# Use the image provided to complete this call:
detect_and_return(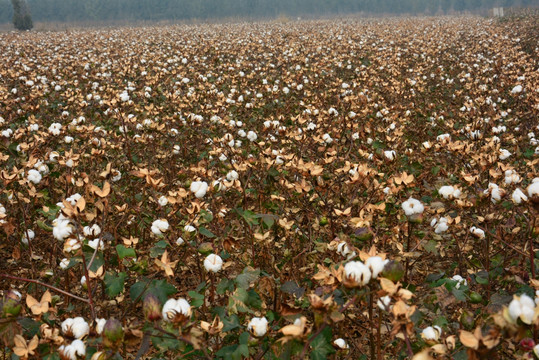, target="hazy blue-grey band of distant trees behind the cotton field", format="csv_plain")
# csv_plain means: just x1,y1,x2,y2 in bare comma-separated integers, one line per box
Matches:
0,0,539,23
